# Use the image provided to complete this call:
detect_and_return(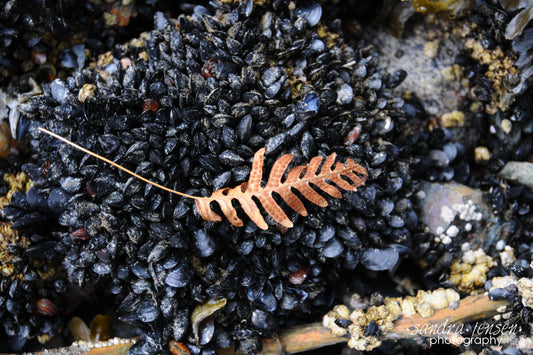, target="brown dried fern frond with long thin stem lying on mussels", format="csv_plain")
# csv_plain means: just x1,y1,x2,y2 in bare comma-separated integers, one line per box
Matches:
39,127,368,229
